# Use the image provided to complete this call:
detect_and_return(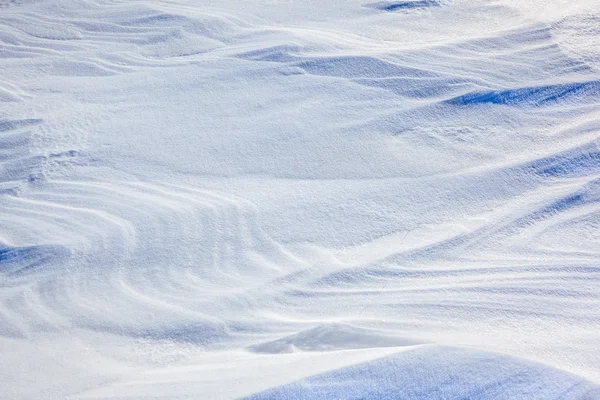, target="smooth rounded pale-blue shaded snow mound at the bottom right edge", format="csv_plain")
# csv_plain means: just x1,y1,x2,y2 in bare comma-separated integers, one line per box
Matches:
248,347,600,400
